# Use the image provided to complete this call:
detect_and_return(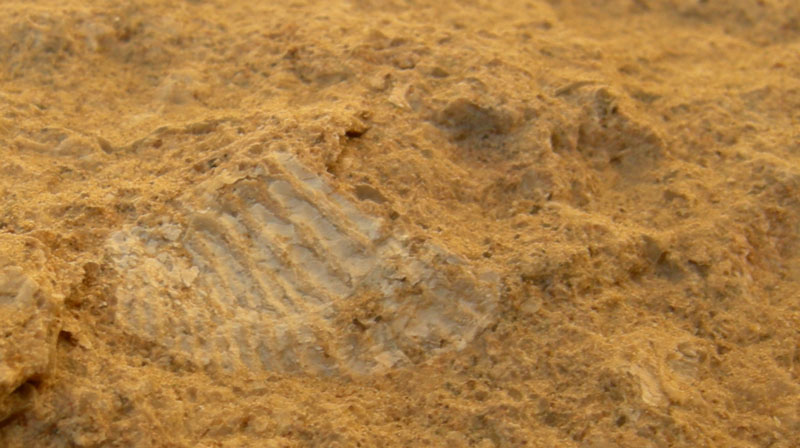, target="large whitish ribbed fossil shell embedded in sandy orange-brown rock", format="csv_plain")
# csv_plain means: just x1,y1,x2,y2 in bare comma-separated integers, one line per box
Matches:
108,153,499,374
